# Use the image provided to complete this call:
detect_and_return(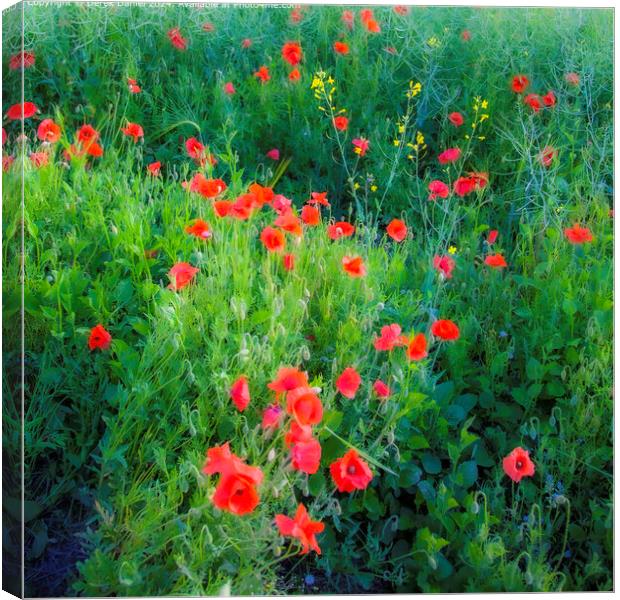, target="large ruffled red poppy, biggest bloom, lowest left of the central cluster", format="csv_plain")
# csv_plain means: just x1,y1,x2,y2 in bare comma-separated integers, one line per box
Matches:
202,442,263,515
